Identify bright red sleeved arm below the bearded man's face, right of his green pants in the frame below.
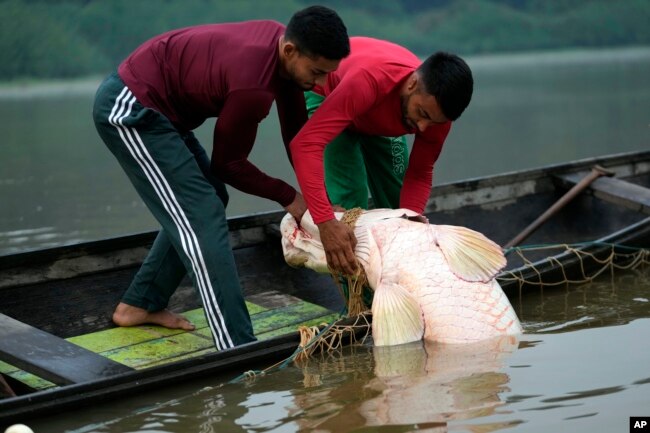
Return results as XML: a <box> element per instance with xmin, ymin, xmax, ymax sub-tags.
<box><xmin>400</xmin><ymin>122</ymin><xmax>451</xmax><ymax>214</ymax></box>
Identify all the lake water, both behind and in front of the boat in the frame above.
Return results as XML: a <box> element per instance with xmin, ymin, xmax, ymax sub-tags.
<box><xmin>0</xmin><ymin>48</ymin><xmax>650</xmax><ymax>433</ymax></box>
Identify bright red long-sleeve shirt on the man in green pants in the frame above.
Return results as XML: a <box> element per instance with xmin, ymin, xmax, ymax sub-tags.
<box><xmin>291</xmin><ymin>37</ymin><xmax>451</xmax><ymax>223</ymax></box>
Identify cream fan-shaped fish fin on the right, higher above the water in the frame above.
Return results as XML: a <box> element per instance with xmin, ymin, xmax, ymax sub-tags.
<box><xmin>430</xmin><ymin>225</ymin><xmax>506</xmax><ymax>282</ymax></box>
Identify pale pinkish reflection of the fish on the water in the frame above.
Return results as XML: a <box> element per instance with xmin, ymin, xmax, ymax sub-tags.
<box><xmin>361</xmin><ymin>336</ymin><xmax>518</xmax><ymax>431</ymax></box>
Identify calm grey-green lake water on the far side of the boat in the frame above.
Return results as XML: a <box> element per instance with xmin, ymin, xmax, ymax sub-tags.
<box><xmin>0</xmin><ymin>47</ymin><xmax>650</xmax><ymax>255</ymax></box>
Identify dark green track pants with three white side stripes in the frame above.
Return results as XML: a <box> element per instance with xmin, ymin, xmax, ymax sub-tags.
<box><xmin>93</xmin><ymin>74</ymin><xmax>255</xmax><ymax>350</ymax></box>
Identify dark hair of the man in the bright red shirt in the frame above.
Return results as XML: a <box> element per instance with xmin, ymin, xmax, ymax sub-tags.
<box><xmin>418</xmin><ymin>52</ymin><xmax>474</xmax><ymax>120</ymax></box>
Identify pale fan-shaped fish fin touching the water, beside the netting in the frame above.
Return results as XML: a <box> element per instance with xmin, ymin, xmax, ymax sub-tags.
<box><xmin>372</xmin><ymin>283</ymin><xmax>424</xmax><ymax>346</ymax></box>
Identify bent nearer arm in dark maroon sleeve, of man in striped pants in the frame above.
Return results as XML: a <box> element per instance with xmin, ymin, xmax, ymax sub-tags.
<box><xmin>211</xmin><ymin>90</ymin><xmax>296</xmax><ymax>207</ymax></box>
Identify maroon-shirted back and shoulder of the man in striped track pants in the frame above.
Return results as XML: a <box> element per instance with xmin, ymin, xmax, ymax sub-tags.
<box><xmin>118</xmin><ymin>21</ymin><xmax>284</xmax><ymax>130</ymax></box>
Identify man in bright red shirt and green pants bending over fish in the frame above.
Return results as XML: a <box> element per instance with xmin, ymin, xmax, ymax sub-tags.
<box><xmin>291</xmin><ymin>37</ymin><xmax>473</xmax><ymax>275</ymax></box>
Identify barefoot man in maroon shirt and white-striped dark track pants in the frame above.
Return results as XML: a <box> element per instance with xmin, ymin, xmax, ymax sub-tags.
<box><xmin>93</xmin><ymin>6</ymin><xmax>350</xmax><ymax>349</ymax></box>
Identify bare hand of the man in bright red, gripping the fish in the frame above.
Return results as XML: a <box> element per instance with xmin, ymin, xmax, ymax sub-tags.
<box><xmin>318</xmin><ymin>218</ymin><xmax>357</xmax><ymax>275</ymax></box>
